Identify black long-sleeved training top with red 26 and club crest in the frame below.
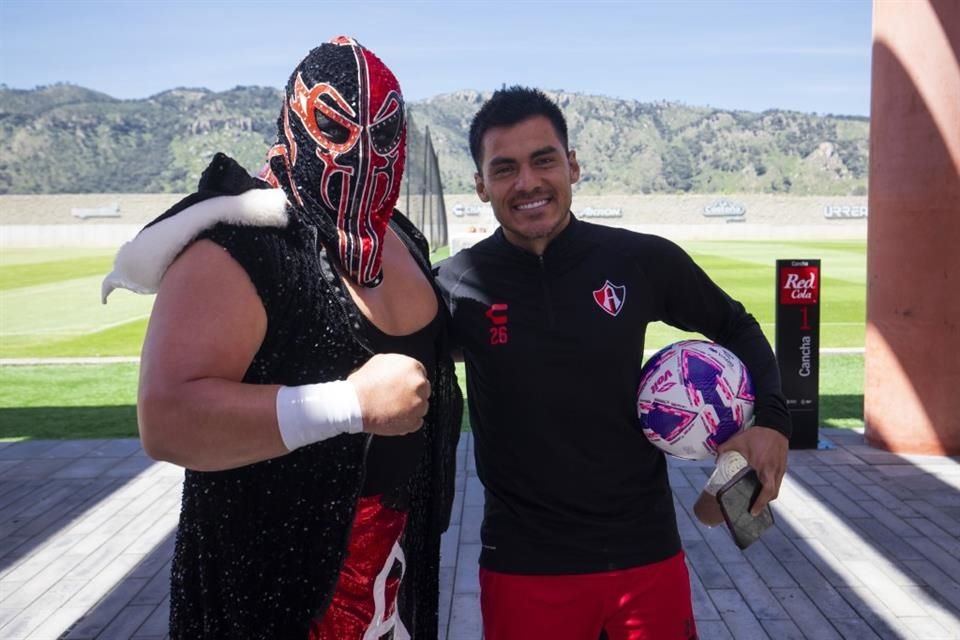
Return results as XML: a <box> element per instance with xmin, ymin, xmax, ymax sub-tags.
<box><xmin>437</xmin><ymin>219</ymin><xmax>790</xmax><ymax>575</ymax></box>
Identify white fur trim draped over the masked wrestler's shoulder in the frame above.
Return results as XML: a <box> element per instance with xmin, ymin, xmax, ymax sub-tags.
<box><xmin>100</xmin><ymin>189</ymin><xmax>287</xmax><ymax>304</ymax></box>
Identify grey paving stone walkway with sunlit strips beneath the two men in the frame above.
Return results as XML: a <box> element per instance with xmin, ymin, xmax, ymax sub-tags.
<box><xmin>0</xmin><ymin>429</ymin><xmax>960</xmax><ymax>640</ymax></box>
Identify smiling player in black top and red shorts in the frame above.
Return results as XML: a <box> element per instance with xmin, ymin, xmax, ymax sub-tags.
<box><xmin>438</xmin><ymin>87</ymin><xmax>790</xmax><ymax>640</ymax></box>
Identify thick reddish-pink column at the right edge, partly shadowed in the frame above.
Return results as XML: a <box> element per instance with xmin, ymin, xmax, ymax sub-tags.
<box><xmin>864</xmin><ymin>0</ymin><xmax>960</xmax><ymax>455</ymax></box>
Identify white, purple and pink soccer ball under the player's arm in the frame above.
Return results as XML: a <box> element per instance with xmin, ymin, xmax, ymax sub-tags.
<box><xmin>637</xmin><ymin>340</ymin><xmax>754</xmax><ymax>460</ymax></box>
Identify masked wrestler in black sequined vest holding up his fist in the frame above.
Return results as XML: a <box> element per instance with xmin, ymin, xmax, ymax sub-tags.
<box><xmin>104</xmin><ymin>37</ymin><xmax>461</xmax><ymax>640</ymax></box>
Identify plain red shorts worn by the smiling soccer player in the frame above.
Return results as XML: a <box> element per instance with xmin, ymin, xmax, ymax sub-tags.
<box><xmin>480</xmin><ymin>552</ymin><xmax>697</xmax><ymax>640</ymax></box>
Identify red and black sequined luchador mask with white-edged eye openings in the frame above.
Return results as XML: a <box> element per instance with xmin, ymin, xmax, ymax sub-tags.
<box><xmin>262</xmin><ymin>36</ymin><xmax>406</xmax><ymax>286</ymax></box>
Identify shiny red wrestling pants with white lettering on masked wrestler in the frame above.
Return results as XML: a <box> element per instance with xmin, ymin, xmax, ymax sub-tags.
<box><xmin>308</xmin><ymin>496</ymin><xmax>410</xmax><ymax>640</ymax></box>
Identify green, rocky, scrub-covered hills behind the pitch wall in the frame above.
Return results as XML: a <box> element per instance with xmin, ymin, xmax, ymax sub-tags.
<box><xmin>0</xmin><ymin>84</ymin><xmax>869</xmax><ymax>195</ymax></box>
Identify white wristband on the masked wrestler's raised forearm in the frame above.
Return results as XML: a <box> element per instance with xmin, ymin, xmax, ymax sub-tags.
<box><xmin>277</xmin><ymin>380</ymin><xmax>363</xmax><ymax>451</ymax></box>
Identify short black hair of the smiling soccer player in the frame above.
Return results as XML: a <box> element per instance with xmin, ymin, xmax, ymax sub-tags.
<box><xmin>470</xmin><ymin>85</ymin><xmax>570</xmax><ymax>171</ymax></box>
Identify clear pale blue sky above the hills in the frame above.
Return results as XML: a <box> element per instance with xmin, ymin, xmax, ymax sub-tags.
<box><xmin>0</xmin><ymin>0</ymin><xmax>871</xmax><ymax>116</ymax></box>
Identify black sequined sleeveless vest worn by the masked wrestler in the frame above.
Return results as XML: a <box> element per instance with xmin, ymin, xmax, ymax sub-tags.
<box><xmin>170</xmin><ymin>213</ymin><xmax>462</xmax><ymax>640</ymax></box>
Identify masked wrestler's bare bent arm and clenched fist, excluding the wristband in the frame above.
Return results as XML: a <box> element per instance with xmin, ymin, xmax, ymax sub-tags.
<box><xmin>138</xmin><ymin>240</ymin><xmax>429</xmax><ymax>471</ymax></box>
